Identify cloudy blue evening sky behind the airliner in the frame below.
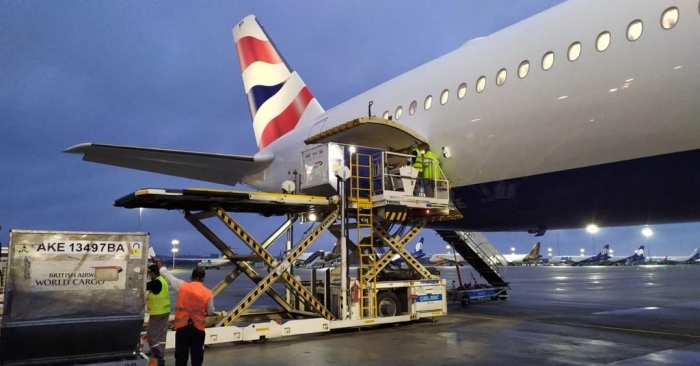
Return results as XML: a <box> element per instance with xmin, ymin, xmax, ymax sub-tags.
<box><xmin>0</xmin><ymin>0</ymin><xmax>699</xmax><ymax>256</ymax></box>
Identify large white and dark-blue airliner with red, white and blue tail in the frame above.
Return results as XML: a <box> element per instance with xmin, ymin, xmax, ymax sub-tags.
<box><xmin>65</xmin><ymin>0</ymin><xmax>700</xmax><ymax>235</ymax></box>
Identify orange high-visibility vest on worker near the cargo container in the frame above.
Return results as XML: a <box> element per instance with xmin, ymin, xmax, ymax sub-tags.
<box><xmin>173</xmin><ymin>281</ymin><xmax>212</xmax><ymax>331</ymax></box>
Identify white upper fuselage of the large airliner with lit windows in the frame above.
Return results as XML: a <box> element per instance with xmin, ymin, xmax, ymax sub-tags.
<box><xmin>243</xmin><ymin>0</ymin><xmax>700</xmax><ymax>191</ymax></box>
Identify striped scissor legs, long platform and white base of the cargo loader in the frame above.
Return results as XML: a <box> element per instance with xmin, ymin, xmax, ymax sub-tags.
<box><xmin>114</xmin><ymin>188</ymin><xmax>447</xmax><ymax>348</ymax></box>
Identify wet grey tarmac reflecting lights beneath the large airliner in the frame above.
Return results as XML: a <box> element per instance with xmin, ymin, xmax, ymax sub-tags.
<box><xmin>166</xmin><ymin>265</ymin><xmax>700</xmax><ymax>366</ymax></box>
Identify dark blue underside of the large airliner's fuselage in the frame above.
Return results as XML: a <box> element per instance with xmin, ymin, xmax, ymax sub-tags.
<box><xmin>438</xmin><ymin>150</ymin><xmax>700</xmax><ymax>231</ymax></box>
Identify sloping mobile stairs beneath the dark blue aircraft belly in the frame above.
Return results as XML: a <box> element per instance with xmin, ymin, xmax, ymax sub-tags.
<box><xmin>437</xmin><ymin>230</ymin><xmax>508</xmax><ymax>287</ymax></box>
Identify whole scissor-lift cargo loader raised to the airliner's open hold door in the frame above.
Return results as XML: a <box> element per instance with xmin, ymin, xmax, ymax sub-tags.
<box><xmin>115</xmin><ymin>133</ymin><xmax>508</xmax><ymax>348</ymax></box>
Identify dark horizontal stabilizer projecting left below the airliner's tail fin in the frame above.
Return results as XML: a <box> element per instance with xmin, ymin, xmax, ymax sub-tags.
<box><xmin>64</xmin><ymin>143</ymin><xmax>274</xmax><ymax>185</ymax></box>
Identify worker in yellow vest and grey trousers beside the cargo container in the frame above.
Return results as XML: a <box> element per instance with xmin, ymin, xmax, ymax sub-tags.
<box><xmin>146</xmin><ymin>264</ymin><xmax>170</xmax><ymax>366</ymax></box>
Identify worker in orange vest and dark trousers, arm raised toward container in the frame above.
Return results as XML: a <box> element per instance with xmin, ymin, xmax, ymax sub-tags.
<box><xmin>154</xmin><ymin>258</ymin><xmax>214</xmax><ymax>366</ymax></box>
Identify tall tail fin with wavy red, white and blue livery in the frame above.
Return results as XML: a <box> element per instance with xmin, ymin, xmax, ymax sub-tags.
<box><xmin>233</xmin><ymin>15</ymin><xmax>324</xmax><ymax>149</ymax></box>
